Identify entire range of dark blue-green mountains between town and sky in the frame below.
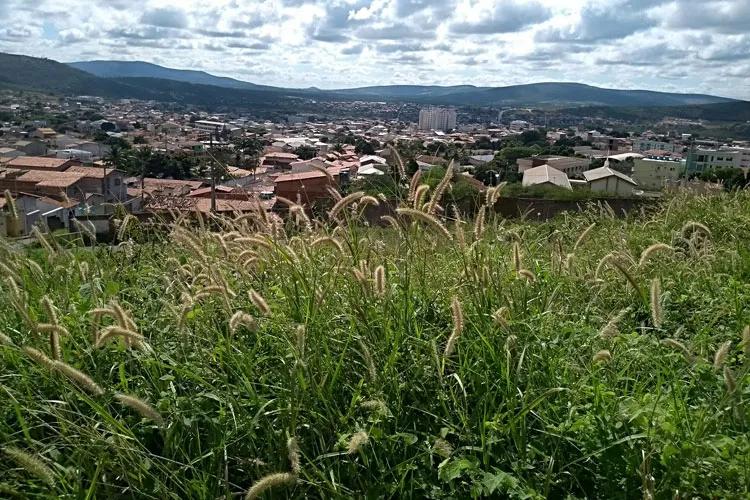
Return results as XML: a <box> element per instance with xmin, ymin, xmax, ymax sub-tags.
<box><xmin>0</xmin><ymin>53</ymin><xmax>750</xmax><ymax>121</ymax></box>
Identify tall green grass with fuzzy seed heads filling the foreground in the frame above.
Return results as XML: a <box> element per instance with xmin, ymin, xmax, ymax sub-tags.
<box><xmin>0</xmin><ymin>186</ymin><xmax>750</xmax><ymax>499</ymax></box>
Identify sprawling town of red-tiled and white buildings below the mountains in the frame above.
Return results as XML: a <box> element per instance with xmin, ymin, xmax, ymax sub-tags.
<box><xmin>0</xmin><ymin>92</ymin><xmax>750</xmax><ymax>236</ymax></box>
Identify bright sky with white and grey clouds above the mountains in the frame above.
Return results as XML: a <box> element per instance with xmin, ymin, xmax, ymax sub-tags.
<box><xmin>0</xmin><ymin>0</ymin><xmax>750</xmax><ymax>100</ymax></box>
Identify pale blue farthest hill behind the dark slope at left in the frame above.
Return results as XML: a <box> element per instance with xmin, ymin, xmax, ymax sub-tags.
<box><xmin>68</xmin><ymin>61</ymin><xmax>281</xmax><ymax>90</ymax></box>
